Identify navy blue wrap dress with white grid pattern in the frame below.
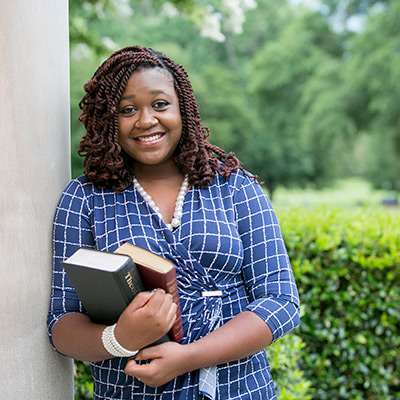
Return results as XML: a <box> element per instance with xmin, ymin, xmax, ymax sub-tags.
<box><xmin>48</xmin><ymin>171</ymin><xmax>299</xmax><ymax>400</ymax></box>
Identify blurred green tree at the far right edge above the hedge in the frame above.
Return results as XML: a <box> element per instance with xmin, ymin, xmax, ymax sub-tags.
<box><xmin>346</xmin><ymin>0</ymin><xmax>400</xmax><ymax>190</ymax></box>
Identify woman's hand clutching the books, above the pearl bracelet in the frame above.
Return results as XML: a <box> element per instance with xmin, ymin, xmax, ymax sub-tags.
<box><xmin>114</xmin><ymin>289</ymin><xmax>177</xmax><ymax>351</ymax></box>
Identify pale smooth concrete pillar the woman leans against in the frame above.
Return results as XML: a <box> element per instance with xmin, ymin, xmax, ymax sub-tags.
<box><xmin>0</xmin><ymin>0</ymin><xmax>73</xmax><ymax>400</ymax></box>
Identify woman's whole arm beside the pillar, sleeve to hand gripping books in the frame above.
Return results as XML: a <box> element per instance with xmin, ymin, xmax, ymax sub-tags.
<box><xmin>48</xmin><ymin>179</ymin><xmax>176</xmax><ymax>361</ymax></box>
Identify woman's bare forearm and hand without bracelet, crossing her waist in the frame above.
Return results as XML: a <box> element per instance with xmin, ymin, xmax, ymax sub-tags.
<box><xmin>125</xmin><ymin>311</ymin><xmax>273</xmax><ymax>387</ymax></box>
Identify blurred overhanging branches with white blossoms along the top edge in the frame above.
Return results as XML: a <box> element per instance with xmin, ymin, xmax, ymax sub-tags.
<box><xmin>69</xmin><ymin>0</ymin><xmax>257</xmax><ymax>54</ymax></box>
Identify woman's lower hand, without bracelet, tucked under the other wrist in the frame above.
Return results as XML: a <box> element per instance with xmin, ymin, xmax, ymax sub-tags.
<box><xmin>125</xmin><ymin>342</ymin><xmax>191</xmax><ymax>387</ymax></box>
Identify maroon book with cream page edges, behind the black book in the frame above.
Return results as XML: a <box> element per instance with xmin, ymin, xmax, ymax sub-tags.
<box><xmin>114</xmin><ymin>242</ymin><xmax>183</xmax><ymax>343</ymax></box>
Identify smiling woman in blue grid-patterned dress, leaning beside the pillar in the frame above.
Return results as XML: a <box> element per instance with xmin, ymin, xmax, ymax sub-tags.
<box><xmin>48</xmin><ymin>46</ymin><xmax>299</xmax><ymax>400</ymax></box>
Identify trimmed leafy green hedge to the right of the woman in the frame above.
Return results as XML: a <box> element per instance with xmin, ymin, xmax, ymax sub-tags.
<box><xmin>278</xmin><ymin>208</ymin><xmax>400</xmax><ymax>400</ymax></box>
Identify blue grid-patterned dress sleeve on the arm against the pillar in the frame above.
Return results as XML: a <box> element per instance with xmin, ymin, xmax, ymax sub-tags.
<box><xmin>47</xmin><ymin>179</ymin><xmax>94</xmax><ymax>347</ymax></box>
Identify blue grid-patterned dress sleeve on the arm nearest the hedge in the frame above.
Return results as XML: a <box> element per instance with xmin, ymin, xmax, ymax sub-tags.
<box><xmin>234</xmin><ymin>179</ymin><xmax>300</xmax><ymax>342</ymax></box>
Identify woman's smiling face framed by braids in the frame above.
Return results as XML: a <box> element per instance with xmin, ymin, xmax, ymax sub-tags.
<box><xmin>118</xmin><ymin>68</ymin><xmax>182</xmax><ymax>167</ymax></box>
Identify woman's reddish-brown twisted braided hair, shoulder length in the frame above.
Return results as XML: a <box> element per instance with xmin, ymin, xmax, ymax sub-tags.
<box><xmin>78</xmin><ymin>46</ymin><xmax>245</xmax><ymax>193</ymax></box>
